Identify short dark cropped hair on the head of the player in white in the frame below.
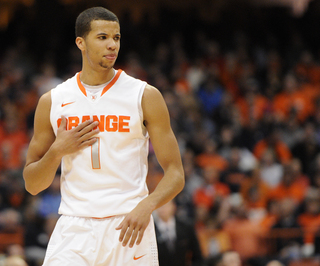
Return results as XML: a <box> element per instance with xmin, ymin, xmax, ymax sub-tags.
<box><xmin>75</xmin><ymin>7</ymin><xmax>120</xmax><ymax>37</ymax></box>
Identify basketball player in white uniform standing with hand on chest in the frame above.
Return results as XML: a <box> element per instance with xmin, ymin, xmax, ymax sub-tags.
<box><xmin>24</xmin><ymin>7</ymin><xmax>184</xmax><ymax>266</ymax></box>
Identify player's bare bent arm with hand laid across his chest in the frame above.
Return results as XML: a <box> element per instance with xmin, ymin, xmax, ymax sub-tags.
<box><xmin>23</xmin><ymin>92</ymin><xmax>99</xmax><ymax>195</ymax></box>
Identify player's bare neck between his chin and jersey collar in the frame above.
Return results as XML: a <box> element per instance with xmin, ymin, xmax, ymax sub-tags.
<box><xmin>80</xmin><ymin>68</ymin><xmax>115</xmax><ymax>86</ymax></box>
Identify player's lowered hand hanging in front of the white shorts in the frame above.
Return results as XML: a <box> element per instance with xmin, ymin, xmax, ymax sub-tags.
<box><xmin>116</xmin><ymin>201</ymin><xmax>152</xmax><ymax>248</ymax></box>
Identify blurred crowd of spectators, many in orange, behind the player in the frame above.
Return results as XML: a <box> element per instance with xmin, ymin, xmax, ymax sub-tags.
<box><xmin>0</xmin><ymin>6</ymin><xmax>320</xmax><ymax>266</ymax></box>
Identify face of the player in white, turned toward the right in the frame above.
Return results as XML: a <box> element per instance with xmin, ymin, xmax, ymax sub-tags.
<box><xmin>85</xmin><ymin>20</ymin><xmax>120</xmax><ymax>69</ymax></box>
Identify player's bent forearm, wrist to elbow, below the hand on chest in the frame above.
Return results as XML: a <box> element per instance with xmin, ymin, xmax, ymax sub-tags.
<box><xmin>23</xmin><ymin>147</ymin><xmax>61</xmax><ymax>195</ymax></box>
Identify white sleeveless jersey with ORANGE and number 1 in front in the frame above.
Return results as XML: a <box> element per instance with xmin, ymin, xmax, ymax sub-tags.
<box><xmin>50</xmin><ymin>70</ymin><xmax>149</xmax><ymax>218</ymax></box>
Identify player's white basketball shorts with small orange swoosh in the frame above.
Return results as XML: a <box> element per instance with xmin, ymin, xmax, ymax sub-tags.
<box><xmin>43</xmin><ymin>215</ymin><xmax>159</xmax><ymax>266</ymax></box>
